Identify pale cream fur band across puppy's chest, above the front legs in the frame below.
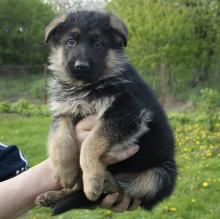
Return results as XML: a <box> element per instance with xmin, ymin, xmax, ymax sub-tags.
<box><xmin>50</xmin><ymin>97</ymin><xmax>114</xmax><ymax>118</ymax></box>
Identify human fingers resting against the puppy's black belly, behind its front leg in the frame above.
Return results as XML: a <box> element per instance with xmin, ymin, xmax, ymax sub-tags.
<box><xmin>102</xmin><ymin>145</ymin><xmax>139</xmax><ymax>165</ymax></box>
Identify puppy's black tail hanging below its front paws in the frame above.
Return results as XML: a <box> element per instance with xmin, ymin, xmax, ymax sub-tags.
<box><xmin>52</xmin><ymin>190</ymin><xmax>105</xmax><ymax>215</ymax></box>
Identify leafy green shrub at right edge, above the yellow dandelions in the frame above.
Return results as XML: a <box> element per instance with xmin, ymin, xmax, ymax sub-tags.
<box><xmin>198</xmin><ymin>88</ymin><xmax>220</xmax><ymax>131</ymax></box>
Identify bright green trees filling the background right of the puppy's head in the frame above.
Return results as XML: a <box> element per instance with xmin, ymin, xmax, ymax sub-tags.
<box><xmin>107</xmin><ymin>0</ymin><xmax>220</xmax><ymax>98</ymax></box>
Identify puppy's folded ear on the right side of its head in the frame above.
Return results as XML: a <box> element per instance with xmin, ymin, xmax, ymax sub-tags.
<box><xmin>109</xmin><ymin>13</ymin><xmax>128</xmax><ymax>47</ymax></box>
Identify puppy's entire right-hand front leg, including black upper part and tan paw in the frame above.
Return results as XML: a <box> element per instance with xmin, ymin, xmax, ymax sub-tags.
<box><xmin>80</xmin><ymin>96</ymin><xmax>147</xmax><ymax>201</ymax></box>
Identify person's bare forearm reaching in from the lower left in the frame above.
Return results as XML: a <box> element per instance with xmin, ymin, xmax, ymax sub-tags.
<box><xmin>0</xmin><ymin>159</ymin><xmax>60</xmax><ymax>219</ymax></box>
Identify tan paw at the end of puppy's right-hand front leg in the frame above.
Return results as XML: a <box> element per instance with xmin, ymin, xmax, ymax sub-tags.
<box><xmin>83</xmin><ymin>174</ymin><xmax>105</xmax><ymax>201</ymax></box>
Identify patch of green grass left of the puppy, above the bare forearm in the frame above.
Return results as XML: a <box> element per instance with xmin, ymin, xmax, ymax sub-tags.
<box><xmin>0</xmin><ymin>114</ymin><xmax>50</xmax><ymax>166</ymax></box>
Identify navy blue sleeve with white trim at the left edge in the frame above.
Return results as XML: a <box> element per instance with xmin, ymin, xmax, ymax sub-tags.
<box><xmin>0</xmin><ymin>143</ymin><xmax>28</xmax><ymax>182</ymax></box>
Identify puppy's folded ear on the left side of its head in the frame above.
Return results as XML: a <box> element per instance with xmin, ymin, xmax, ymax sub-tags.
<box><xmin>44</xmin><ymin>15</ymin><xmax>67</xmax><ymax>43</ymax></box>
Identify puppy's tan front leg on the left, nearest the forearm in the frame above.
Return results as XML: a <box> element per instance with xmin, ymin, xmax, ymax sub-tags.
<box><xmin>49</xmin><ymin>116</ymin><xmax>79</xmax><ymax>189</ymax></box>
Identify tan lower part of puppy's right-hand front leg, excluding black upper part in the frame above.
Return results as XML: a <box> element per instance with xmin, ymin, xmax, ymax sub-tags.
<box><xmin>80</xmin><ymin>122</ymin><xmax>110</xmax><ymax>201</ymax></box>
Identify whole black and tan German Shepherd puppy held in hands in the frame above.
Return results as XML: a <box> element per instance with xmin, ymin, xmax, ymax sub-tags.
<box><xmin>38</xmin><ymin>11</ymin><xmax>176</xmax><ymax>214</ymax></box>
